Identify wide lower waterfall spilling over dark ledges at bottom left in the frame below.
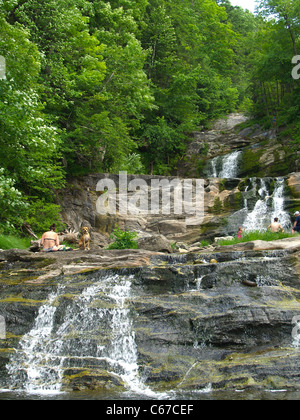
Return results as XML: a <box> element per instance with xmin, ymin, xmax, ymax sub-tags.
<box><xmin>6</xmin><ymin>275</ymin><xmax>162</xmax><ymax>397</ymax></box>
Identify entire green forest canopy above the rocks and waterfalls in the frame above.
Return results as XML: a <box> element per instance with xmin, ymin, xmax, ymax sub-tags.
<box><xmin>0</xmin><ymin>0</ymin><xmax>300</xmax><ymax>232</ymax></box>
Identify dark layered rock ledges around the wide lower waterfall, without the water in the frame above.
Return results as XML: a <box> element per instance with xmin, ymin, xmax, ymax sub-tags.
<box><xmin>0</xmin><ymin>238</ymin><xmax>300</xmax><ymax>391</ymax></box>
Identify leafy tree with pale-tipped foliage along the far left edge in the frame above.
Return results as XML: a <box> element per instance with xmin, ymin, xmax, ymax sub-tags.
<box><xmin>0</xmin><ymin>13</ymin><xmax>64</xmax><ymax>227</ymax></box>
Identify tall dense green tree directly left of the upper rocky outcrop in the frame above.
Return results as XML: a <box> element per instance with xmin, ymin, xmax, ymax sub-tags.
<box><xmin>140</xmin><ymin>0</ymin><xmax>238</xmax><ymax>174</ymax></box>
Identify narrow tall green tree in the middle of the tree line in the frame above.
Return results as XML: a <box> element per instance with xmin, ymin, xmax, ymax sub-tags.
<box><xmin>86</xmin><ymin>0</ymin><xmax>154</xmax><ymax>171</ymax></box>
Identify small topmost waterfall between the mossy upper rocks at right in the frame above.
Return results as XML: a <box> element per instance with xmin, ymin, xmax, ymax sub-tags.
<box><xmin>208</xmin><ymin>150</ymin><xmax>242</xmax><ymax>178</ymax></box>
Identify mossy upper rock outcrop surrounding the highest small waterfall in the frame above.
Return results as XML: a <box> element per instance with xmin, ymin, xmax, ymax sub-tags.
<box><xmin>178</xmin><ymin>114</ymin><xmax>300</xmax><ymax>178</ymax></box>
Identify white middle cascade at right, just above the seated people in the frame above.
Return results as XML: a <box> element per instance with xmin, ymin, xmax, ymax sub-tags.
<box><xmin>243</xmin><ymin>178</ymin><xmax>291</xmax><ymax>232</ymax></box>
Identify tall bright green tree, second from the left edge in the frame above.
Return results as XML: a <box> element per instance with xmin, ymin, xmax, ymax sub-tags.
<box><xmin>14</xmin><ymin>0</ymin><xmax>106</xmax><ymax>172</ymax></box>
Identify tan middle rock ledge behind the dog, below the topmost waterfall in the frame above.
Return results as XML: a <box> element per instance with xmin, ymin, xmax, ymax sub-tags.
<box><xmin>58</xmin><ymin>172</ymin><xmax>300</xmax><ymax>252</ymax></box>
